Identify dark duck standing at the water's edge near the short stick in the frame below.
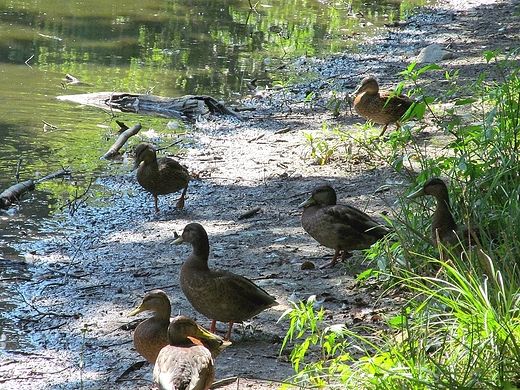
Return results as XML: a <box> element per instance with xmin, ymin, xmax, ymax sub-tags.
<box><xmin>134</xmin><ymin>143</ymin><xmax>190</xmax><ymax>213</ymax></box>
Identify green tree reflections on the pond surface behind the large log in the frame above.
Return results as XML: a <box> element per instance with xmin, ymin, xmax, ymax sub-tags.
<box><xmin>0</xmin><ymin>0</ymin><xmax>423</xmax><ymax>99</ymax></box>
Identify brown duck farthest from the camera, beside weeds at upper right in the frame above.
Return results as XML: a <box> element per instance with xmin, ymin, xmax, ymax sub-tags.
<box><xmin>353</xmin><ymin>77</ymin><xmax>415</xmax><ymax>136</ymax></box>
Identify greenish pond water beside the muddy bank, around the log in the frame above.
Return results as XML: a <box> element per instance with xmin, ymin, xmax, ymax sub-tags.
<box><xmin>0</xmin><ymin>0</ymin><xmax>425</xmax><ymax>350</ymax></box>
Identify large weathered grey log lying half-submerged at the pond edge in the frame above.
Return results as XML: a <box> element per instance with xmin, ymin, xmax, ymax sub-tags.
<box><xmin>58</xmin><ymin>92</ymin><xmax>241</xmax><ymax>119</ymax></box>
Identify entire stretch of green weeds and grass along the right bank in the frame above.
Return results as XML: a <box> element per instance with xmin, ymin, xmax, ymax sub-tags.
<box><xmin>283</xmin><ymin>51</ymin><xmax>520</xmax><ymax>389</ymax></box>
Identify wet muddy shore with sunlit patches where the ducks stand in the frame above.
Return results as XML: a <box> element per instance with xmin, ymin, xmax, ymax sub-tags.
<box><xmin>0</xmin><ymin>0</ymin><xmax>520</xmax><ymax>389</ymax></box>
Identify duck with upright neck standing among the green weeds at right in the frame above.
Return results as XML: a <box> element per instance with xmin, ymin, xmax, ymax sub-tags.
<box><xmin>407</xmin><ymin>177</ymin><xmax>467</xmax><ymax>258</ymax></box>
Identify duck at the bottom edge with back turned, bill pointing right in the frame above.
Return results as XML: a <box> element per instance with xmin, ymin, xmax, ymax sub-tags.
<box><xmin>153</xmin><ymin>316</ymin><xmax>221</xmax><ymax>390</ymax></box>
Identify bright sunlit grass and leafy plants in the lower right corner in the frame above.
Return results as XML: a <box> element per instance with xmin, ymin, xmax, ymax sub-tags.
<box><xmin>280</xmin><ymin>252</ymin><xmax>520</xmax><ymax>390</ymax></box>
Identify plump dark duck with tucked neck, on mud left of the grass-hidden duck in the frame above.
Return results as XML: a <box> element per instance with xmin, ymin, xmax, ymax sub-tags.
<box><xmin>299</xmin><ymin>185</ymin><xmax>389</xmax><ymax>268</ymax></box>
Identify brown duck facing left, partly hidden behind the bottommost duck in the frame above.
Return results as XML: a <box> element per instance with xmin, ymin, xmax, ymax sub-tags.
<box><xmin>128</xmin><ymin>289</ymin><xmax>231</xmax><ymax>364</ymax></box>
